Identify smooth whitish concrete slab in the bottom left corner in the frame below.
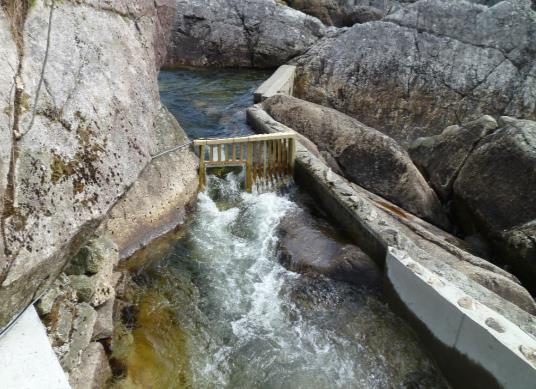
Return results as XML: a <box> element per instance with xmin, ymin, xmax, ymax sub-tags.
<box><xmin>0</xmin><ymin>306</ymin><xmax>70</xmax><ymax>389</ymax></box>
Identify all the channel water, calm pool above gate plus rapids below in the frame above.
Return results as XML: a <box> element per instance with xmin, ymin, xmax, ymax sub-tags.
<box><xmin>114</xmin><ymin>70</ymin><xmax>447</xmax><ymax>389</ymax></box>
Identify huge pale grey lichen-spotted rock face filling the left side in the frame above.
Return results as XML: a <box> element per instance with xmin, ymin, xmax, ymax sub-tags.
<box><xmin>0</xmin><ymin>0</ymin><xmax>174</xmax><ymax>326</ymax></box>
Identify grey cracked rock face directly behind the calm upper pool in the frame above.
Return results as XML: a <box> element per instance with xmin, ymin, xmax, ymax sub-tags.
<box><xmin>166</xmin><ymin>0</ymin><xmax>325</xmax><ymax>67</ymax></box>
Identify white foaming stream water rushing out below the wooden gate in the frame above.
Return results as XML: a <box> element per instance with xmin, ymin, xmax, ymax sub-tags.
<box><xmin>117</xmin><ymin>174</ymin><xmax>444</xmax><ymax>389</ymax></box>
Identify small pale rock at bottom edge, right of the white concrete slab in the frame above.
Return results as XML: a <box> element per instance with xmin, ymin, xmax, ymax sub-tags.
<box><xmin>69</xmin><ymin>342</ymin><xmax>112</xmax><ymax>389</ymax></box>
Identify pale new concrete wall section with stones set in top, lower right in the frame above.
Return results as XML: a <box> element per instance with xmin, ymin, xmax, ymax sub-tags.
<box><xmin>386</xmin><ymin>247</ymin><xmax>536</xmax><ymax>388</ymax></box>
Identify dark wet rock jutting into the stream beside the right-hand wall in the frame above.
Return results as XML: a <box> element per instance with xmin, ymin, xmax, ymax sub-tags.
<box><xmin>279</xmin><ymin>203</ymin><xmax>381</xmax><ymax>289</ymax></box>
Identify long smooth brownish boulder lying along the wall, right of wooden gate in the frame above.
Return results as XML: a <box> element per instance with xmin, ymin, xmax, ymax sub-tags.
<box><xmin>263</xmin><ymin>95</ymin><xmax>448</xmax><ymax>226</ymax></box>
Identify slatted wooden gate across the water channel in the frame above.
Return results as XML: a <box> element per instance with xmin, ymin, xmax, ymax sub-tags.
<box><xmin>194</xmin><ymin>132</ymin><xmax>296</xmax><ymax>192</ymax></box>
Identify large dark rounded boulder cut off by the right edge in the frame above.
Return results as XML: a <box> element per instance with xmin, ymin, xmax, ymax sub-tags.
<box><xmin>454</xmin><ymin>117</ymin><xmax>536</xmax><ymax>285</ymax></box>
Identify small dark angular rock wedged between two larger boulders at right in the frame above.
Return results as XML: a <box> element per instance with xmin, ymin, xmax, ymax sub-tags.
<box><xmin>408</xmin><ymin>116</ymin><xmax>498</xmax><ymax>201</ymax></box>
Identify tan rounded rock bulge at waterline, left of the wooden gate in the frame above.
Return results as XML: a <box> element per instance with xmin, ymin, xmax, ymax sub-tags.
<box><xmin>99</xmin><ymin>107</ymin><xmax>199</xmax><ymax>258</ymax></box>
